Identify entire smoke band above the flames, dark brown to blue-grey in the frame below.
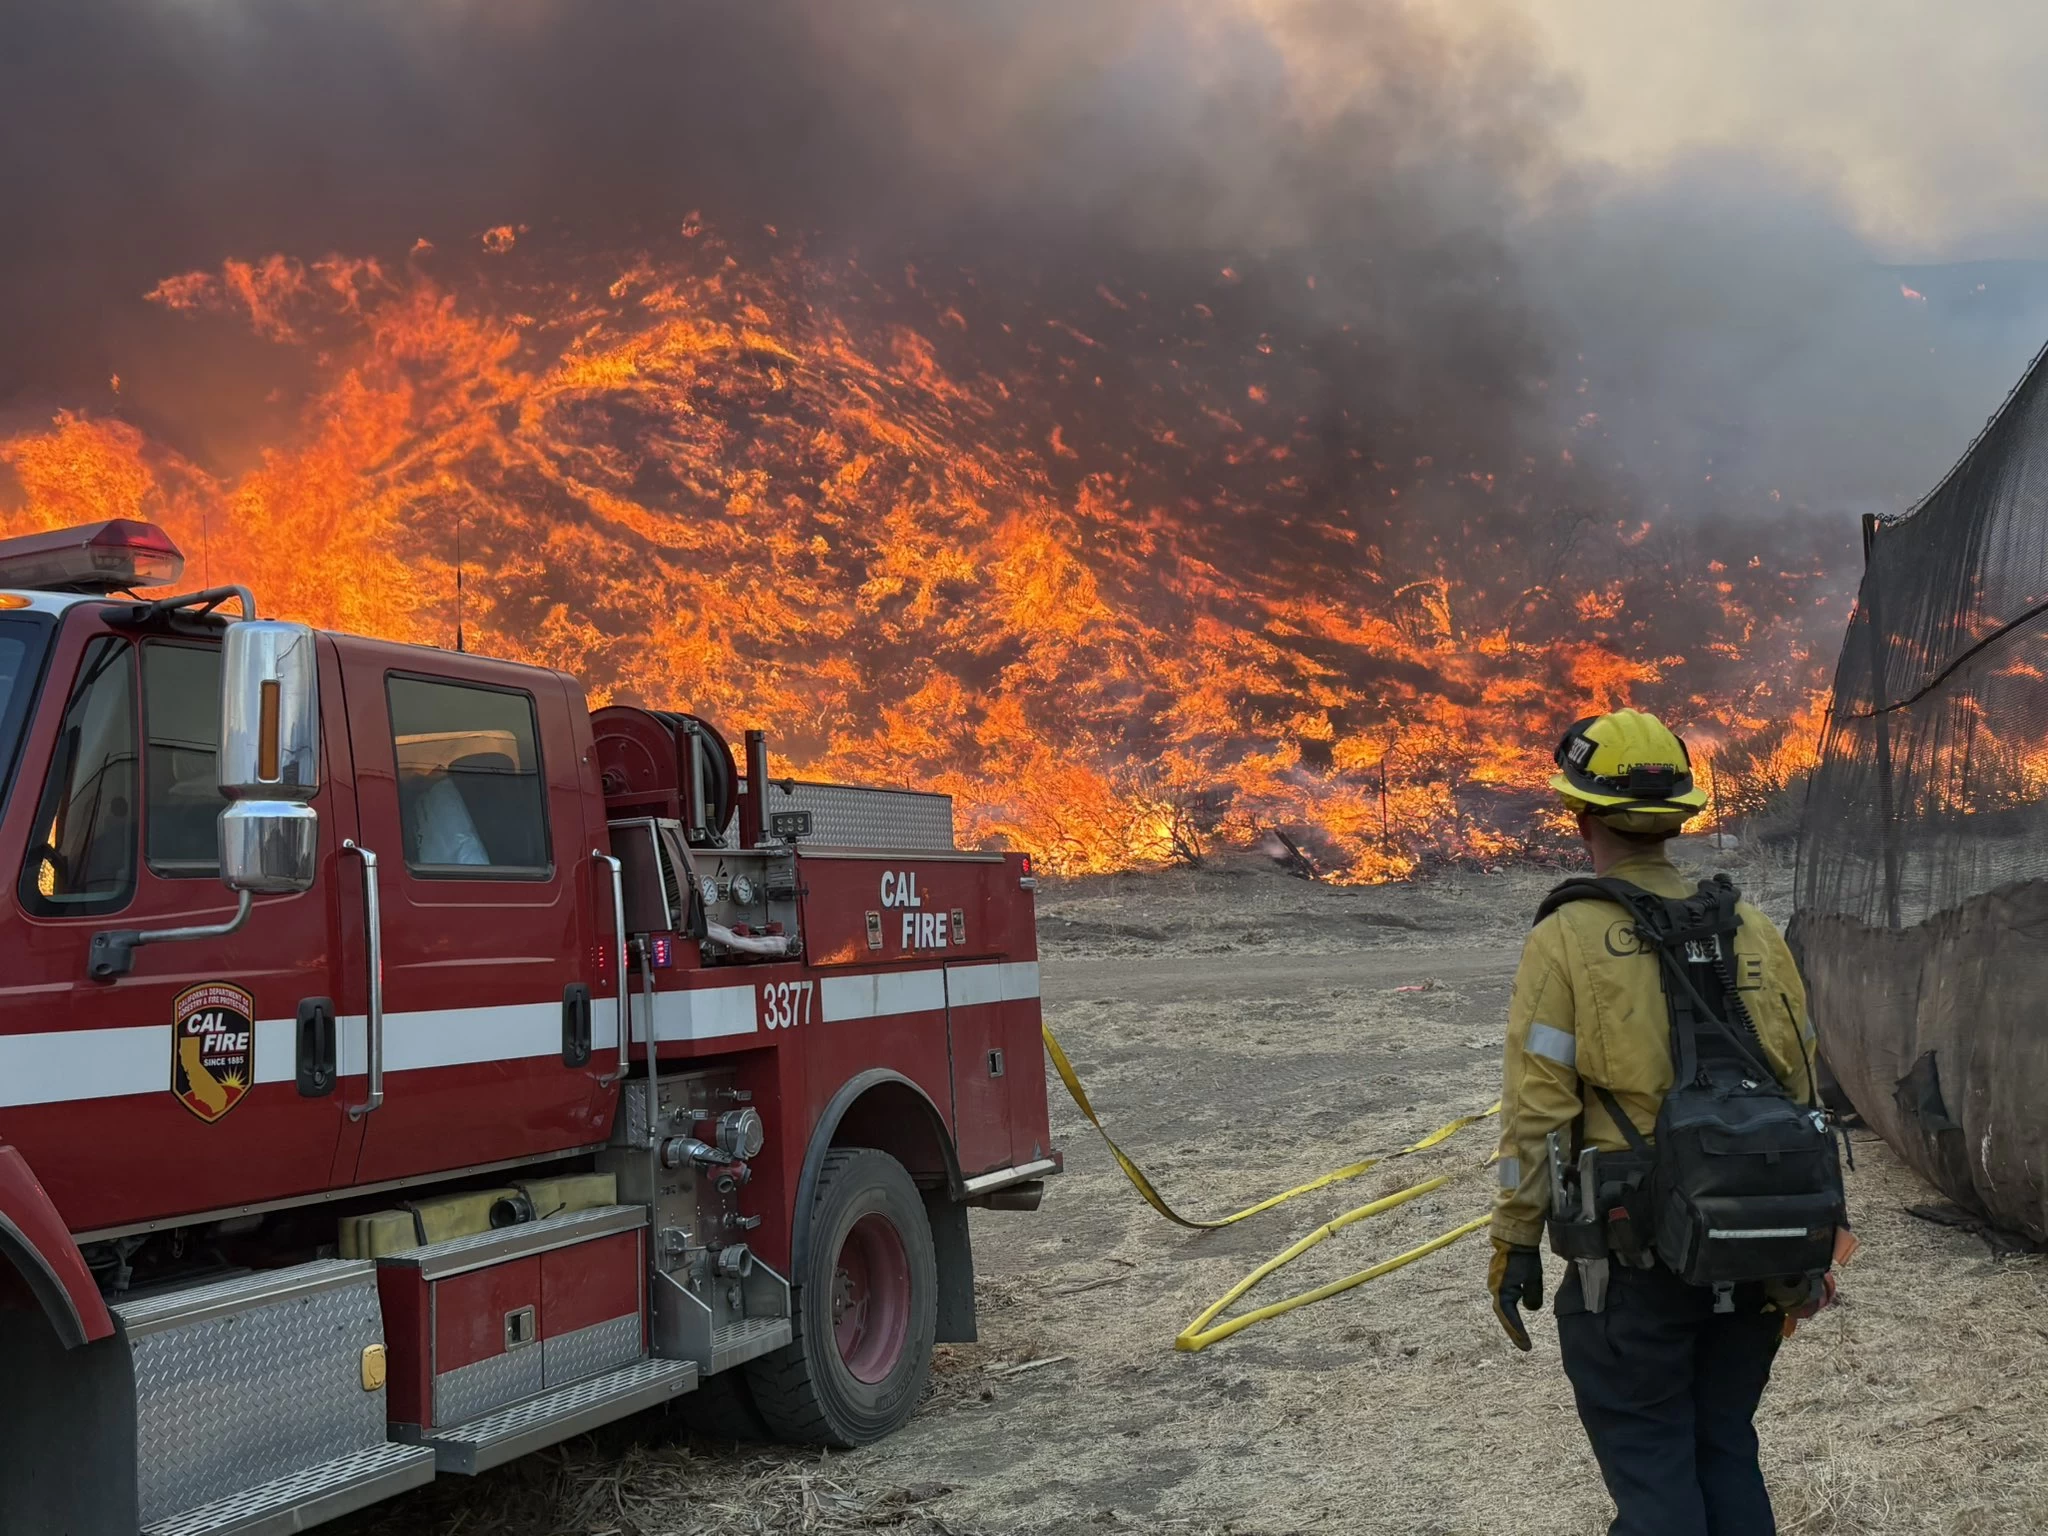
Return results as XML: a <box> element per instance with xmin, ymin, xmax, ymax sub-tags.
<box><xmin>12</xmin><ymin>0</ymin><xmax>2040</xmax><ymax>508</ymax></box>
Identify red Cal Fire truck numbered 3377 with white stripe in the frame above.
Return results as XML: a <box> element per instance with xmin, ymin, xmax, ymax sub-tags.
<box><xmin>0</xmin><ymin>520</ymin><xmax>1059</xmax><ymax>1536</ymax></box>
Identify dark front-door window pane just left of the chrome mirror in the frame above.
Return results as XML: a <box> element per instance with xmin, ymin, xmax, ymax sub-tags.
<box><xmin>141</xmin><ymin>641</ymin><xmax>227</xmax><ymax>877</ymax></box>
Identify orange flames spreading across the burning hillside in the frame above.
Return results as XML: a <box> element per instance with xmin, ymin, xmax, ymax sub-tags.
<box><xmin>0</xmin><ymin>228</ymin><xmax>1839</xmax><ymax>879</ymax></box>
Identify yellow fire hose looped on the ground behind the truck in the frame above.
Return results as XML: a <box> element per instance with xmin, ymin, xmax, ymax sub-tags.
<box><xmin>1040</xmin><ymin>1026</ymin><xmax>1501</xmax><ymax>1352</ymax></box>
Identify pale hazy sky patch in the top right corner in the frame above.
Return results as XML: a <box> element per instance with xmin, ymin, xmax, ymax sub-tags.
<box><xmin>1515</xmin><ymin>0</ymin><xmax>2048</xmax><ymax>260</ymax></box>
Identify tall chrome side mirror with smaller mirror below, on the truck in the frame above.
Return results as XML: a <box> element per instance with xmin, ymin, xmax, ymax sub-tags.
<box><xmin>215</xmin><ymin>618</ymin><xmax>319</xmax><ymax>895</ymax></box>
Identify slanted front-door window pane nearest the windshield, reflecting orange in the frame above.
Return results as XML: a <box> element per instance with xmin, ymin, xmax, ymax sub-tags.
<box><xmin>18</xmin><ymin>639</ymin><xmax>137</xmax><ymax>918</ymax></box>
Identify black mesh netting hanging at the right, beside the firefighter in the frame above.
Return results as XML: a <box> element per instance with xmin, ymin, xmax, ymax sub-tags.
<box><xmin>1796</xmin><ymin>354</ymin><xmax>2048</xmax><ymax>1239</ymax></box>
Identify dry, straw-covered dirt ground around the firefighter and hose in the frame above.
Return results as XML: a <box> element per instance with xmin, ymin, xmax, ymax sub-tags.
<box><xmin>348</xmin><ymin>846</ymin><xmax>2048</xmax><ymax>1536</ymax></box>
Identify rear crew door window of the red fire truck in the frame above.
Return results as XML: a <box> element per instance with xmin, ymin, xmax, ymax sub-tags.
<box><xmin>385</xmin><ymin>676</ymin><xmax>551</xmax><ymax>881</ymax></box>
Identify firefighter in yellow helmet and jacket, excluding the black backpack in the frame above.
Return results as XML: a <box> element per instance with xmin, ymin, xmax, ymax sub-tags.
<box><xmin>1487</xmin><ymin>709</ymin><xmax>1812</xmax><ymax>1536</ymax></box>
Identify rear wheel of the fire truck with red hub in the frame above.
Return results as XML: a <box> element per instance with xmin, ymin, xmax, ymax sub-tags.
<box><xmin>748</xmin><ymin>1147</ymin><xmax>938</xmax><ymax>1446</ymax></box>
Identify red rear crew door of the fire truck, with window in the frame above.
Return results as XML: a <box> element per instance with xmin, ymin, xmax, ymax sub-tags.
<box><xmin>344</xmin><ymin>641</ymin><xmax>616</xmax><ymax>1182</ymax></box>
